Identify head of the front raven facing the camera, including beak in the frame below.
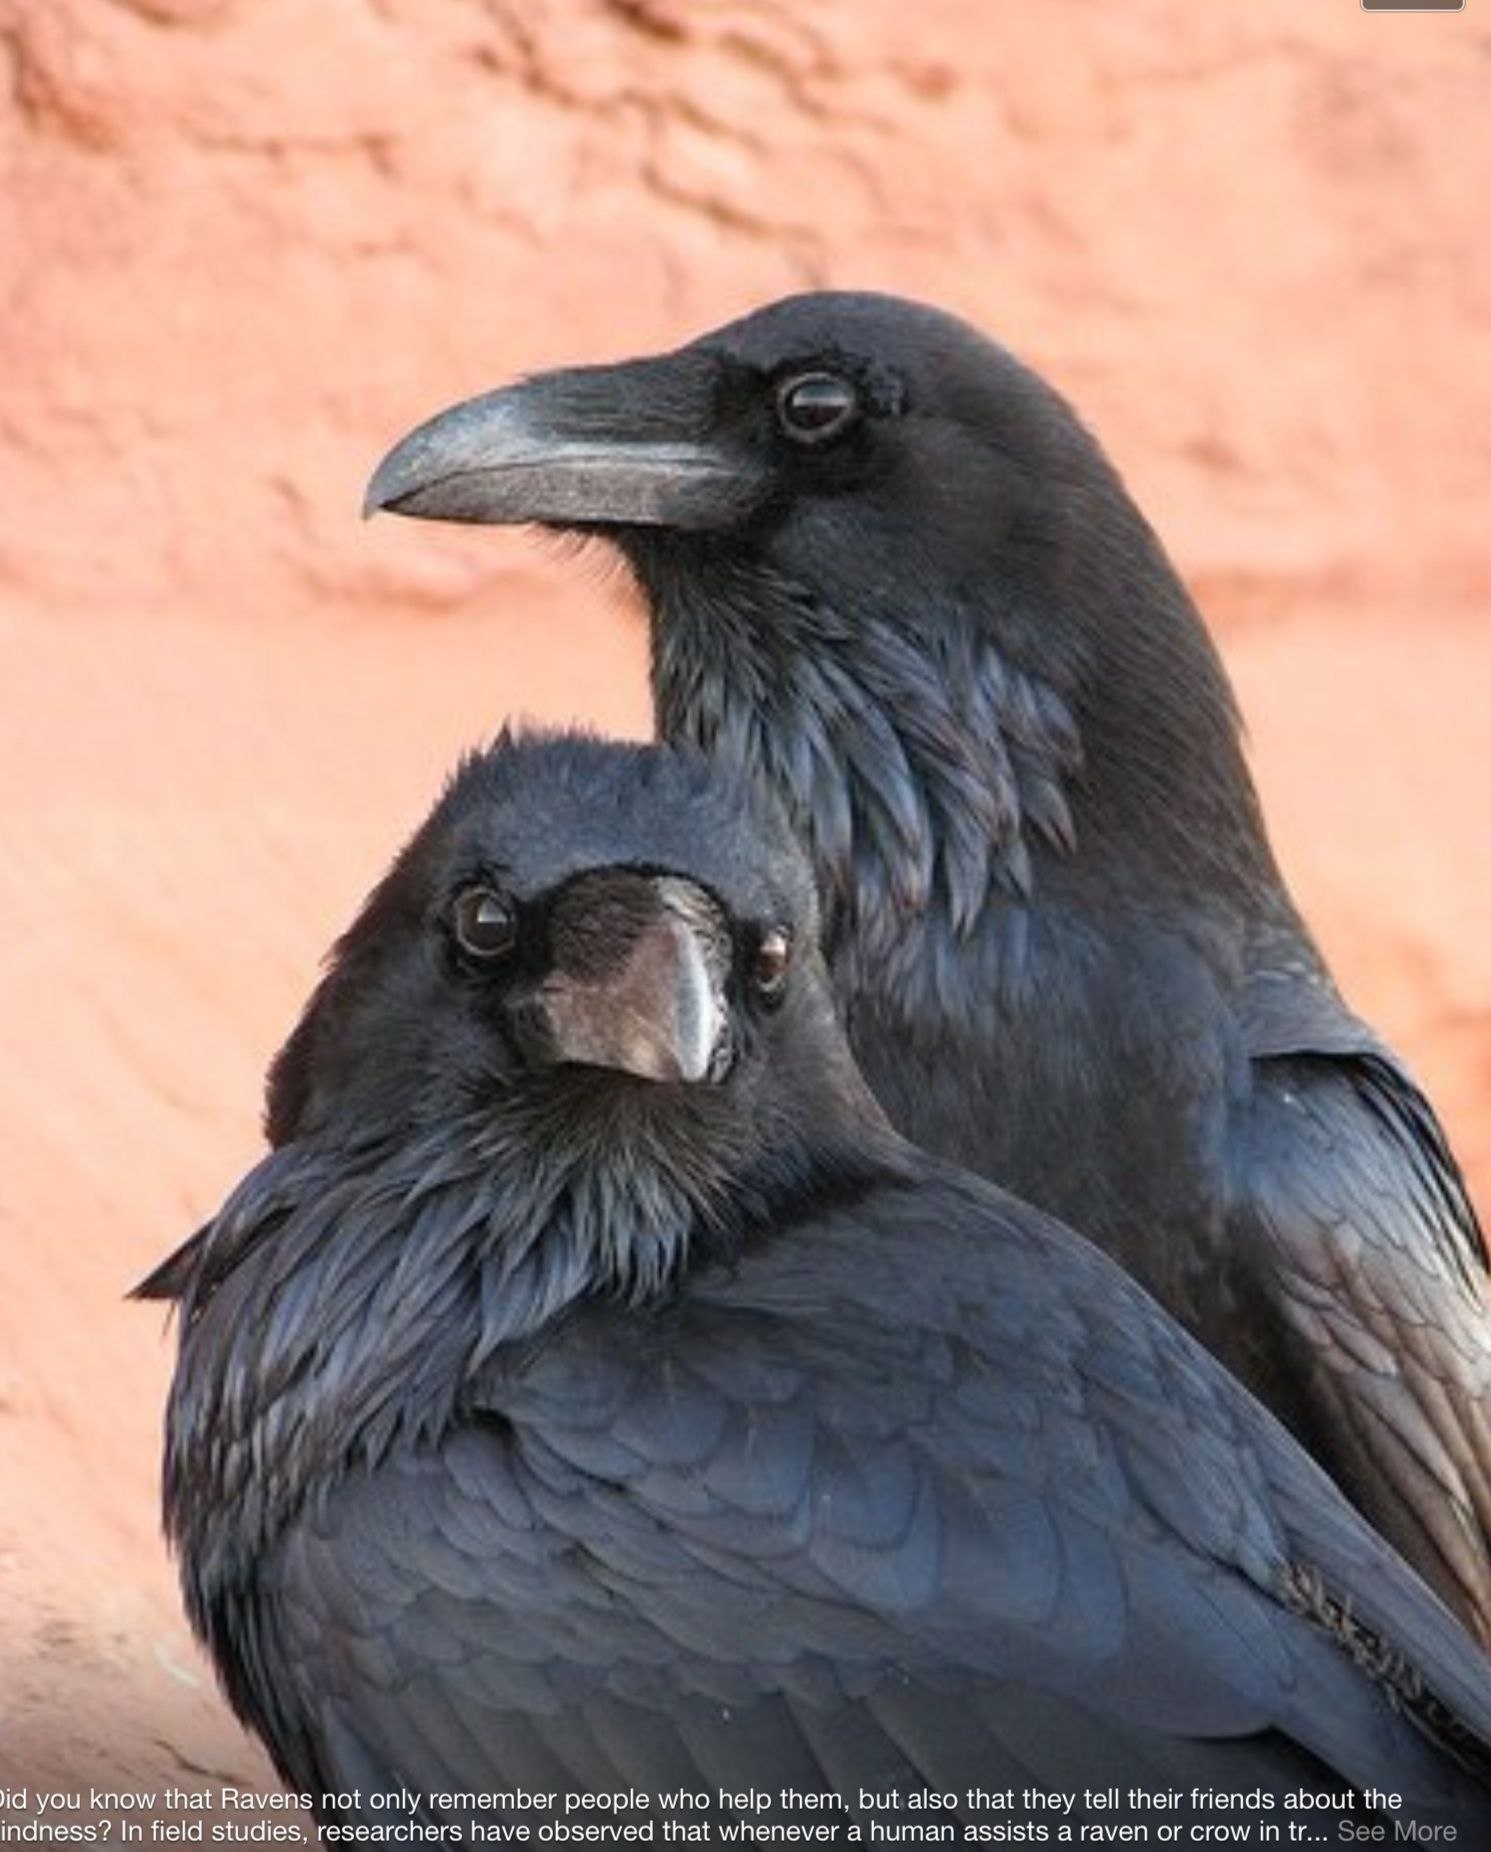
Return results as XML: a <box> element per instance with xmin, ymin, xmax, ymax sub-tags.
<box><xmin>267</xmin><ymin>735</ymin><xmax>866</xmax><ymax>1148</ymax></box>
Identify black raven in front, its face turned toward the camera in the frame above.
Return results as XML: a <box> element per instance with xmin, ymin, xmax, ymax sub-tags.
<box><xmin>141</xmin><ymin>737</ymin><xmax>1491</xmax><ymax>1843</ymax></box>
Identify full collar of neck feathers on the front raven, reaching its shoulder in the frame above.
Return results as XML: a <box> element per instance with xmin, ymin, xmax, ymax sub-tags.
<box><xmin>165</xmin><ymin>1070</ymin><xmax>898</xmax><ymax>1611</ymax></box>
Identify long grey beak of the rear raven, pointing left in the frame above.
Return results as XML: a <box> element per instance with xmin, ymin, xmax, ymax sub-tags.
<box><xmin>363</xmin><ymin>348</ymin><xmax>765</xmax><ymax>530</ymax></box>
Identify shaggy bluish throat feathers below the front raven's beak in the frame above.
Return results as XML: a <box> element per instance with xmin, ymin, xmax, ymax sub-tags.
<box><xmin>167</xmin><ymin>1120</ymin><xmax>726</xmax><ymax>1565</ymax></box>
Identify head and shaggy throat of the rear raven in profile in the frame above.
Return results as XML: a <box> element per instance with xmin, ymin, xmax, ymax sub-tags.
<box><xmin>367</xmin><ymin>293</ymin><xmax>1258</xmax><ymax>985</ymax></box>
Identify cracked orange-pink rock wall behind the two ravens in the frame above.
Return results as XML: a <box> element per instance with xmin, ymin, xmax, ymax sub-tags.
<box><xmin>0</xmin><ymin>0</ymin><xmax>1491</xmax><ymax>1787</ymax></box>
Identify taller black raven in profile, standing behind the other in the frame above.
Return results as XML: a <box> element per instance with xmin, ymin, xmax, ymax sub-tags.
<box><xmin>369</xmin><ymin>294</ymin><xmax>1491</xmax><ymax>1639</ymax></box>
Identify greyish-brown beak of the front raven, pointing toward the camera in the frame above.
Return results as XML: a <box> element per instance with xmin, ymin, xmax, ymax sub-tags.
<box><xmin>533</xmin><ymin>896</ymin><xmax>730</xmax><ymax>1082</ymax></box>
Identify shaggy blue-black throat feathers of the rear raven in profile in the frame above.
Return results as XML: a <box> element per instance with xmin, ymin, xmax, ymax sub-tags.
<box><xmin>648</xmin><ymin>572</ymin><xmax>1082</xmax><ymax>969</ymax></box>
